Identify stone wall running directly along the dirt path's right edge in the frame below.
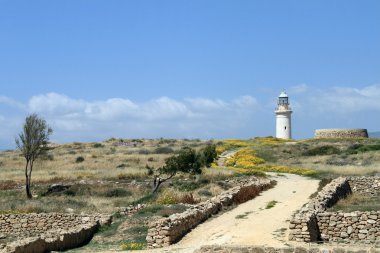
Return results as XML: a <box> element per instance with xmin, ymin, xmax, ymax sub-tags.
<box><xmin>289</xmin><ymin>177</ymin><xmax>351</xmax><ymax>242</ymax></box>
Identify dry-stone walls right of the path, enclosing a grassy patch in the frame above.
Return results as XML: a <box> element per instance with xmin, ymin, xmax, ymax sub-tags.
<box><xmin>289</xmin><ymin>177</ymin><xmax>380</xmax><ymax>244</ymax></box>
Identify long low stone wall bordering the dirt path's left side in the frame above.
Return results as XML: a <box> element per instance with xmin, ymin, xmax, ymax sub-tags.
<box><xmin>147</xmin><ymin>178</ymin><xmax>274</xmax><ymax>248</ymax></box>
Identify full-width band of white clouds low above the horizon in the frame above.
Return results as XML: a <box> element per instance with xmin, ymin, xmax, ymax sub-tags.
<box><xmin>0</xmin><ymin>84</ymin><xmax>380</xmax><ymax>147</ymax></box>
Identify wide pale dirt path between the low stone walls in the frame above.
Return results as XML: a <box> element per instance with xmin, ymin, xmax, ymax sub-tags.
<box><xmin>146</xmin><ymin>174</ymin><xmax>318</xmax><ymax>253</ymax></box>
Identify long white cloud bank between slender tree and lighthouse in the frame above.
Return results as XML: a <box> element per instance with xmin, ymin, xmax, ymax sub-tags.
<box><xmin>0</xmin><ymin>93</ymin><xmax>259</xmax><ymax>142</ymax></box>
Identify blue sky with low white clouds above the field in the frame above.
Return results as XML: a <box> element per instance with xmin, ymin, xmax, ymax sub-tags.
<box><xmin>0</xmin><ymin>0</ymin><xmax>380</xmax><ymax>149</ymax></box>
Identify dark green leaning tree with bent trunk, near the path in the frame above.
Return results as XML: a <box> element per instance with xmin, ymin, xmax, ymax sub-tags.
<box><xmin>151</xmin><ymin>148</ymin><xmax>202</xmax><ymax>192</ymax></box>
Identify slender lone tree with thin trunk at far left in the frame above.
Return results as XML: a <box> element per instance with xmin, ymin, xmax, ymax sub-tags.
<box><xmin>16</xmin><ymin>114</ymin><xmax>53</xmax><ymax>199</ymax></box>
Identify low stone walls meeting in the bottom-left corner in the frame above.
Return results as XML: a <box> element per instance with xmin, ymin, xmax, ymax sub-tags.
<box><xmin>0</xmin><ymin>213</ymin><xmax>112</xmax><ymax>253</ymax></box>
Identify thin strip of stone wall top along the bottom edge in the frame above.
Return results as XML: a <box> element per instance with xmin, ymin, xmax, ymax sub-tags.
<box><xmin>194</xmin><ymin>245</ymin><xmax>380</xmax><ymax>253</ymax></box>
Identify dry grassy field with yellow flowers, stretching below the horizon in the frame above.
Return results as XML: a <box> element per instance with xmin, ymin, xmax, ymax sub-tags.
<box><xmin>0</xmin><ymin>137</ymin><xmax>380</xmax><ymax>249</ymax></box>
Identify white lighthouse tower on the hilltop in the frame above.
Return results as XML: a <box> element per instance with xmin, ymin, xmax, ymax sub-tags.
<box><xmin>275</xmin><ymin>91</ymin><xmax>293</xmax><ymax>139</ymax></box>
